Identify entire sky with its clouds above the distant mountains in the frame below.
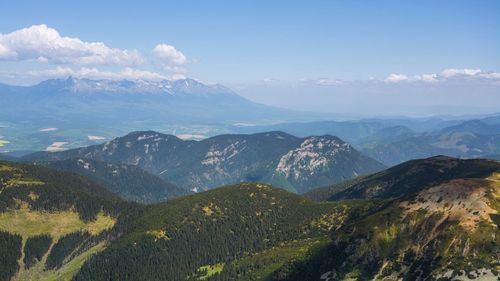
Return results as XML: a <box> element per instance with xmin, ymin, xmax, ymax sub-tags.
<box><xmin>0</xmin><ymin>0</ymin><xmax>500</xmax><ymax>115</ymax></box>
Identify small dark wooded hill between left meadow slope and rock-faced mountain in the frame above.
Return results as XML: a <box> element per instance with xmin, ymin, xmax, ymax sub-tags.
<box><xmin>39</xmin><ymin>158</ymin><xmax>186</xmax><ymax>203</ymax></box>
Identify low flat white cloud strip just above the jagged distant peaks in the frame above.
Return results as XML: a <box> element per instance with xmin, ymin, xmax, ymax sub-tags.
<box><xmin>29</xmin><ymin>66</ymin><xmax>174</xmax><ymax>81</ymax></box>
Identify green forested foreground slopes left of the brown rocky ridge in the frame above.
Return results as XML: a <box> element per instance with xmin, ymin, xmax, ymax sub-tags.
<box><xmin>0</xmin><ymin>162</ymin><xmax>380</xmax><ymax>280</ymax></box>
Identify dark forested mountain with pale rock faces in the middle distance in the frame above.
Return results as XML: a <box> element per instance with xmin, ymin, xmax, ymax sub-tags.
<box><xmin>23</xmin><ymin>131</ymin><xmax>384</xmax><ymax>193</ymax></box>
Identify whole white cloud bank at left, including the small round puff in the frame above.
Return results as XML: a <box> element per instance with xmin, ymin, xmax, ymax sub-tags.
<box><xmin>0</xmin><ymin>24</ymin><xmax>189</xmax><ymax>80</ymax></box>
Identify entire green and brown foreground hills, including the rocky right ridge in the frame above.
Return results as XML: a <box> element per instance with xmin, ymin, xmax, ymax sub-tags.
<box><xmin>0</xmin><ymin>156</ymin><xmax>500</xmax><ymax>281</ymax></box>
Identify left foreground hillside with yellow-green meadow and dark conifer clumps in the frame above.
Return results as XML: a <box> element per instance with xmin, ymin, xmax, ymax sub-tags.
<box><xmin>0</xmin><ymin>161</ymin><xmax>139</xmax><ymax>280</ymax></box>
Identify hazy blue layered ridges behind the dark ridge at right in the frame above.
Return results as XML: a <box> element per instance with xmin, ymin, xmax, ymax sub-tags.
<box><xmin>235</xmin><ymin>116</ymin><xmax>500</xmax><ymax>166</ymax></box>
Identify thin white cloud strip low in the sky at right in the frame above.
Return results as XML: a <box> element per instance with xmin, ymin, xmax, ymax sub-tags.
<box><xmin>384</xmin><ymin>68</ymin><xmax>500</xmax><ymax>83</ymax></box>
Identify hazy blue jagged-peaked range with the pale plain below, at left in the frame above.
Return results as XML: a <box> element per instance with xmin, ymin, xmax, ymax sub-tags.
<box><xmin>0</xmin><ymin>77</ymin><xmax>324</xmax><ymax>152</ymax></box>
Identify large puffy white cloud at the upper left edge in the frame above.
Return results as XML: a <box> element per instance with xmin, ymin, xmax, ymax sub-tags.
<box><xmin>0</xmin><ymin>24</ymin><xmax>143</xmax><ymax>65</ymax></box>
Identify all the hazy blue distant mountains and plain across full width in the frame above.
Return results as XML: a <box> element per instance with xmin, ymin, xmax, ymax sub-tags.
<box><xmin>0</xmin><ymin>77</ymin><xmax>500</xmax><ymax>166</ymax></box>
